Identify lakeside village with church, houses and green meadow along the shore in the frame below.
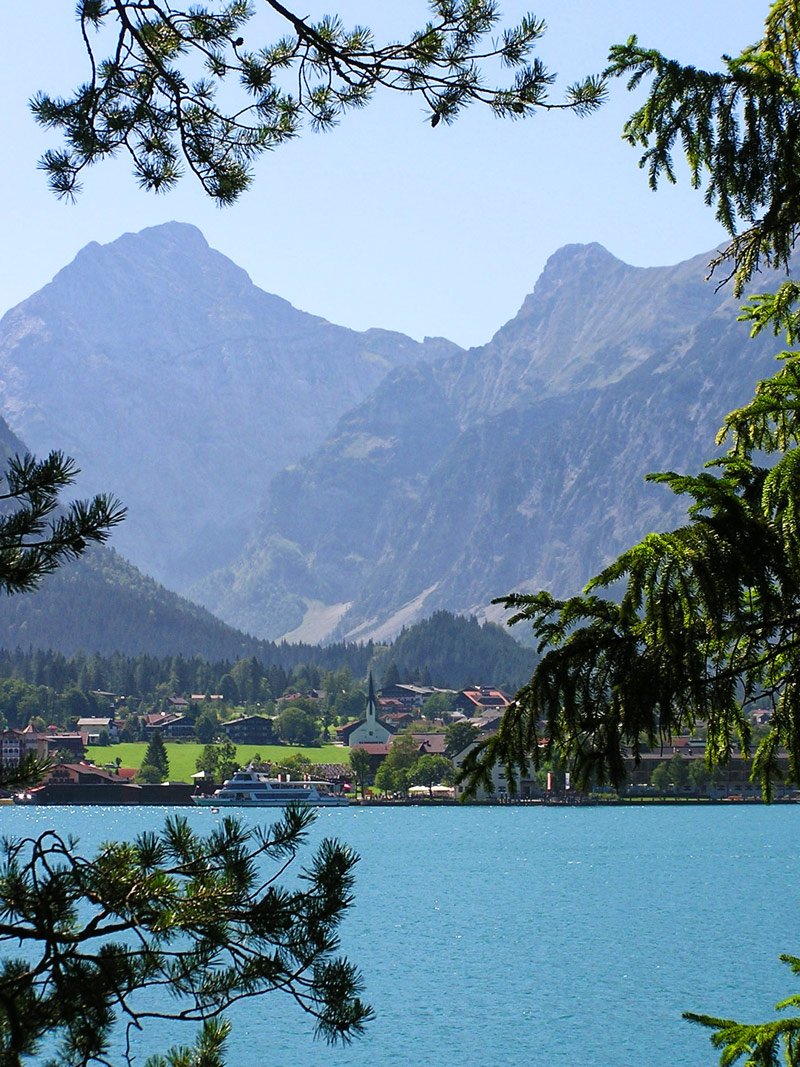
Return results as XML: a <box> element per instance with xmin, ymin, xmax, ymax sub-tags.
<box><xmin>0</xmin><ymin>674</ymin><xmax>796</xmax><ymax>806</ymax></box>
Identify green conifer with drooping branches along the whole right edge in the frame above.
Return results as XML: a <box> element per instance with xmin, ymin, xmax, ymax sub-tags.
<box><xmin>465</xmin><ymin>0</ymin><xmax>800</xmax><ymax>1067</ymax></box>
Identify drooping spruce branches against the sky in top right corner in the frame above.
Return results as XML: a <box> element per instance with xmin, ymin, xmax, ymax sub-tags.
<box><xmin>606</xmin><ymin>0</ymin><xmax>800</xmax><ymax>296</ymax></box>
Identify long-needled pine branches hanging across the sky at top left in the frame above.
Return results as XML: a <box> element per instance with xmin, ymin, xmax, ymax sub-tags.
<box><xmin>31</xmin><ymin>0</ymin><xmax>605</xmax><ymax>204</ymax></box>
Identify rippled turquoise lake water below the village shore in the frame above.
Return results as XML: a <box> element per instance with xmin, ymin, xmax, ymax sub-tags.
<box><xmin>6</xmin><ymin>806</ymin><xmax>800</xmax><ymax>1067</ymax></box>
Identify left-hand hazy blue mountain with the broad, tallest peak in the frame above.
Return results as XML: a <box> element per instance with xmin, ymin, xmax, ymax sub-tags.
<box><xmin>0</xmin><ymin>223</ymin><xmax>459</xmax><ymax>591</ymax></box>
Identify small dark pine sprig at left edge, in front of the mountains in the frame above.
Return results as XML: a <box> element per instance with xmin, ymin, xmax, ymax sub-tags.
<box><xmin>0</xmin><ymin>451</ymin><xmax>125</xmax><ymax>593</ymax></box>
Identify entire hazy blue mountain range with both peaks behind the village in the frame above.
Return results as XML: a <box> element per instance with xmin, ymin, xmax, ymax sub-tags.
<box><xmin>0</xmin><ymin>223</ymin><xmax>789</xmax><ymax>640</ymax></box>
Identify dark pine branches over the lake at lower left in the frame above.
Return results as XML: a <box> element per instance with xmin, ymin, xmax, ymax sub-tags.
<box><xmin>0</xmin><ymin>809</ymin><xmax>371</xmax><ymax>1067</ymax></box>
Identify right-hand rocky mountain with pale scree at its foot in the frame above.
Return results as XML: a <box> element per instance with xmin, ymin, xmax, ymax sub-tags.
<box><xmin>195</xmin><ymin>244</ymin><xmax>793</xmax><ymax>640</ymax></box>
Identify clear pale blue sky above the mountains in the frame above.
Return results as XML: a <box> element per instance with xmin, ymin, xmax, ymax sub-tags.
<box><xmin>0</xmin><ymin>0</ymin><xmax>767</xmax><ymax>347</ymax></box>
